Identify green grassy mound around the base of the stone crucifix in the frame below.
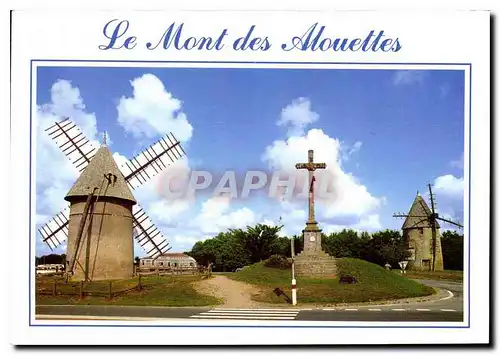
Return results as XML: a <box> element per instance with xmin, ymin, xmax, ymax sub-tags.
<box><xmin>227</xmin><ymin>258</ymin><xmax>433</xmax><ymax>304</ymax></box>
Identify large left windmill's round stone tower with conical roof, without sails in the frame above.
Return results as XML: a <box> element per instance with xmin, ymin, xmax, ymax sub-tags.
<box><xmin>65</xmin><ymin>144</ymin><xmax>136</xmax><ymax>280</ymax></box>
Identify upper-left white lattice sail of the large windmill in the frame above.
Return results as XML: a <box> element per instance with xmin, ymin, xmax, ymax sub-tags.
<box><xmin>46</xmin><ymin>118</ymin><xmax>97</xmax><ymax>172</ymax></box>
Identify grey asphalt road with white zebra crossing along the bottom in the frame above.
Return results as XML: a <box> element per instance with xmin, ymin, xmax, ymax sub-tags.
<box><xmin>36</xmin><ymin>280</ymin><xmax>463</xmax><ymax>322</ymax></box>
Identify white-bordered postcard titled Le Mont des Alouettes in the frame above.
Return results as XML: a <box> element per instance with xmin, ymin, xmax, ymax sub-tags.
<box><xmin>10</xmin><ymin>4</ymin><xmax>490</xmax><ymax>346</ymax></box>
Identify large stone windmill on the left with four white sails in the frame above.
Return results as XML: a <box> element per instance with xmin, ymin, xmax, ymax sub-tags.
<box><xmin>39</xmin><ymin>119</ymin><xmax>185</xmax><ymax>281</ymax></box>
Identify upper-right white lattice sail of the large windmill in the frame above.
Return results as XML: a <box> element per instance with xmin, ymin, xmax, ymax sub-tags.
<box><xmin>120</xmin><ymin>134</ymin><xmax>184</xmax><ymax>189</ymax></box>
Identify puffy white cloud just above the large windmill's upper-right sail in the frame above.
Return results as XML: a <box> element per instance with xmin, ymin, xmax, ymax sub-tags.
<box><xmin>117</xmin><ymin>74</ymin><xmax>193</xmax><ymax>142</ymax></box>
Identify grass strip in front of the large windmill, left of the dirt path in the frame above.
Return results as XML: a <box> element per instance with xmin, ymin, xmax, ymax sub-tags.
<box><xmin>36</xmin><ymin>276</ymin><xmax>220</xmax><ymax>307</ymax></box>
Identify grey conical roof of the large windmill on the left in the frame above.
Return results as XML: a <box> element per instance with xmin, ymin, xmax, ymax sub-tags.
<box><xmin>64</xmin><ymin>145</ymin><xmax>137</xmax><ymax>204</ymax></box>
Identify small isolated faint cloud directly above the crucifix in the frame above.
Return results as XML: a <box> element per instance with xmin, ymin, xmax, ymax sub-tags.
<box><xmin>276</xmin><ymin>97</ymin><xmax>319</xmax><ymax>136</ymax></box>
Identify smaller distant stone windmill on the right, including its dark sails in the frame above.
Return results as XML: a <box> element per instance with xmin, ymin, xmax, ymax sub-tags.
<box><xmin>393</xmin><ymin>184</ymin><xmax>462</xmax><ymax>271</ymax></box>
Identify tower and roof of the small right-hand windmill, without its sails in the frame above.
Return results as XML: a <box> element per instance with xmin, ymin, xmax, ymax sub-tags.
<box><xmin>402</xmin><ymin>193</ymin><xmax>443</xmax><ymax>271</ymax></box>
